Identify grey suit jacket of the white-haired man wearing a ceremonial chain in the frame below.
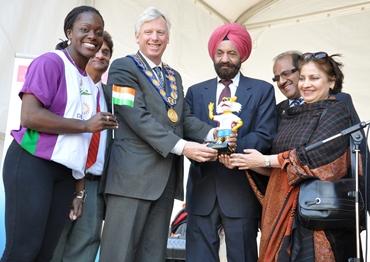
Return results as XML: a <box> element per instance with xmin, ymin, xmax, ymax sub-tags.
<box><xmin>105</xmin><ymin>53</ymin><xmax>211</xmax><ymax>200</ymax></box>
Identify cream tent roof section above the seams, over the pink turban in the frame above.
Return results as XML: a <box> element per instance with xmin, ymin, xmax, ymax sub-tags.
<box><xmin>195</xmin><ymin>0</ymin><xmax>370</xmax><ymax>28</ymax></box>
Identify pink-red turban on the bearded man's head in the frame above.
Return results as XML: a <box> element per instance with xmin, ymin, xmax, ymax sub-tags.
<box><xmin>208</xmin><ymin>23</ymin><xmax>252</xmax><ymax>63</ymax></box>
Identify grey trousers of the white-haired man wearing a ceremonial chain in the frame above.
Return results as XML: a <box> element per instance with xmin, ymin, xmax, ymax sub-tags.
<box><xmin>100</xmin><ymin>163</ymin><xmax>176</xmax><ymax>262</ymax></box>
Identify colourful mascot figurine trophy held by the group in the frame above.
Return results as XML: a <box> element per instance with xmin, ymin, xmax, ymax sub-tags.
<box><xmin>208</xmin><ymin>96</ymin><xmax>243</xmax><ymax>154</ymax></box>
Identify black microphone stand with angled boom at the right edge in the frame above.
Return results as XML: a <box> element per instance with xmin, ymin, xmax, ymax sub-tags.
<box><xmin>305</xmin><ymin>121</ymin><xmax>370</xmax><ymax>262</ymax></box>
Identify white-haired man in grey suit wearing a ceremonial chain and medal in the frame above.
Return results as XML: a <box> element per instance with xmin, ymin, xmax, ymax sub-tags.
<box><xmin>100</xmin><ymin>8</ymin><xmax>217</xmax><ymax>262</ymax></box>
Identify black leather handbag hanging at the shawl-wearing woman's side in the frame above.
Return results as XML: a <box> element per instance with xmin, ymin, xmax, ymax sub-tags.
<box><xmin>297</xmin><ymin>139</ymin><xmax>365</xmax><ymax>230</ymax></box>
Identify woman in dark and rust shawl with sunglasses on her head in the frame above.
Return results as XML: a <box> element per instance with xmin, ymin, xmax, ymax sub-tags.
<box><xmin>220</xmin><ymin>52</ymin><xmax>356</xmax><ymax>262</ymax></box>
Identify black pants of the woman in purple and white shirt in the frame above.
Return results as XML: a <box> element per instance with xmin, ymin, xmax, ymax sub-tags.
<box><xmin>1</xmin><ymin>141</ymin><xmax>75</xmax><ymax>262</ymax></box>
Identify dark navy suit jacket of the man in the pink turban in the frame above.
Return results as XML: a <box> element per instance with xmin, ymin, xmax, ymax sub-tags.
<box><xmin>186</xmin><ymin>75</ymin><xmax>276</xmax><ymax>217</ymax></box>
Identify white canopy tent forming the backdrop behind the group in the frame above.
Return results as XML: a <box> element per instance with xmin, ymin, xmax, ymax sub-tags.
<box><xmin>0</xmin><ymin>0</ymin><xmax>370</xmax><ymax>256</ymax></box>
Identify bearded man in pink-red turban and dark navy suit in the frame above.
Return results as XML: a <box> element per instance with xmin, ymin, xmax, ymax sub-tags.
<box><xmin>186</xmin><ymin>23</ymin><xmax>276</xmax><ymax>262</ymax></box>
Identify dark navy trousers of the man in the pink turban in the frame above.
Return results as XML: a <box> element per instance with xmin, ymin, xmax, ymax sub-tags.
<box><xmin>186</xmin><ymin>201</ymin><xmax>258</xmax><ymax>262</ymax></box>
